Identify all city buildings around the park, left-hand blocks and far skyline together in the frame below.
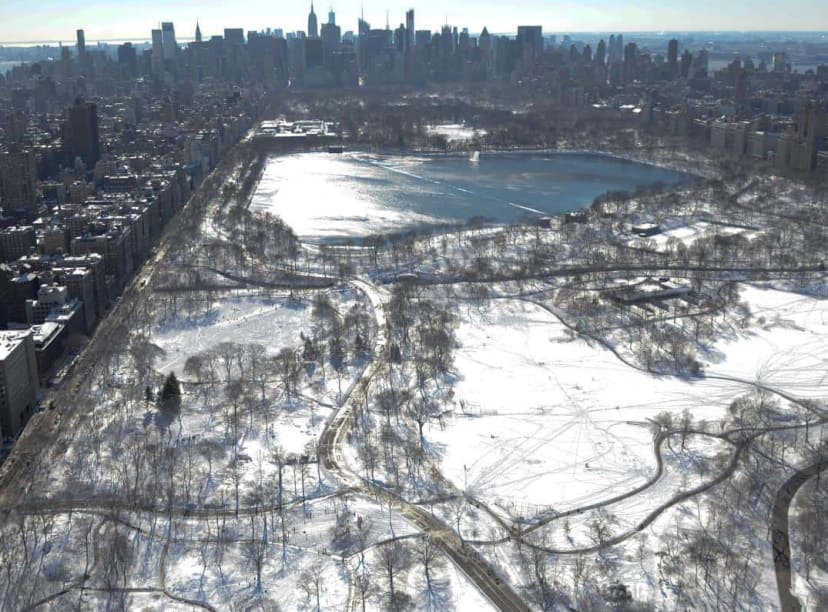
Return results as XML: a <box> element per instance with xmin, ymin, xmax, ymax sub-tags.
<box><xmin>0</xmin><ymin>7</ymin><xmax>828</xmax><ymax>434</ymax></box>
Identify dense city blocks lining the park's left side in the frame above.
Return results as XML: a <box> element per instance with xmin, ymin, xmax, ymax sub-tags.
<box><xmin>0</xmin><ymin>49</ymin><xmax>265</xmax><ymax>438</ymax></box>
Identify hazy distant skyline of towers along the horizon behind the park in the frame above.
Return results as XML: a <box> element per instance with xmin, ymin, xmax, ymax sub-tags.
<box><xmin>40</xmin><ymin>11</ymin><xmax>828</xmax><ymax>172</ymax></box>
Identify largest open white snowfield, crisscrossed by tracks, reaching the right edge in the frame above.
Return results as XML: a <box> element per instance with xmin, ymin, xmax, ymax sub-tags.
<box><xmin>427</xmin><ymin>287</ymin><xmax>828</xmax><ymax>516</ymax></box>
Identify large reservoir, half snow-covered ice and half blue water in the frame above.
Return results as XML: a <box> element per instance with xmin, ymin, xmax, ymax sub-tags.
<box><xmin>252</xmin><ymin>153</ymin><xmax>689</xmax><ymax>242</ymax></box>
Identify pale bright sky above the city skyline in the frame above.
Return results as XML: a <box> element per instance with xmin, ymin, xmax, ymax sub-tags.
<box><xmin>0</xmin><ymin>0</ymin><xmax>828</xmax><ymax>44</ymax></box>
